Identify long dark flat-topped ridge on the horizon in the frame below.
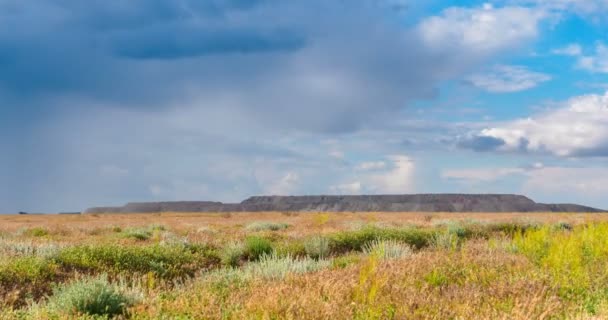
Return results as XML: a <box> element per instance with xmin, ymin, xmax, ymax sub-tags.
<box><xmin>85</xmin><ymin>194</ymin><xmax>605</xmax><ymax>213</ymax></box>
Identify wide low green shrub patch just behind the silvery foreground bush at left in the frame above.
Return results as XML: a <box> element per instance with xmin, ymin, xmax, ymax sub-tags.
<box><xmin>56</xmin><ymin>245</ymin><xmax>219</xmax><ymax>278</ymax></box>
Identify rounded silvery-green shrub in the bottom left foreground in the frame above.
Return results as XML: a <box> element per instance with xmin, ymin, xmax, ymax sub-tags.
<box><xmin>48</xmin><ymin>275</ymin><xmax>136</xmax><ymax>317</ymax></box>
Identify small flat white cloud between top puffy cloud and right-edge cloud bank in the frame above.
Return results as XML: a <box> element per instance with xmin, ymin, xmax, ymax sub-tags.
<box><xmin>467</xmin><ymin>65</ymin><xmax>551</xmax><ymax>93</ymax></box>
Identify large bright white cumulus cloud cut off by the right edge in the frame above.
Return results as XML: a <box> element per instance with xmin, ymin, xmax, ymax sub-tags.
<box><xmin>476</xmin><ymin>92</ymin><xmax>608</xmax><ymax>157</ymax></box>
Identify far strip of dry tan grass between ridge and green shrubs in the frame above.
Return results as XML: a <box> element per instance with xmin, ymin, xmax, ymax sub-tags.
<box><xmin>0</xmin><ymin>212</ymin><xmax>608</xmax><ymax>237</ymax></box>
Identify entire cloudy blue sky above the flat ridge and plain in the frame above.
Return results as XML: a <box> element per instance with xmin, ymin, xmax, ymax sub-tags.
<box><xmin>0</xmin><ymin>0</ymin><xmax>608</xmax><ymax>213</ymax></box>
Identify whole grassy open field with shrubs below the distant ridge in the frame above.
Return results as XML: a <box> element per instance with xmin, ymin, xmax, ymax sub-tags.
<box><xmin>0</xmin><ymin>212</ymin><xmax>608</xmax><ymax>319</ymax></box>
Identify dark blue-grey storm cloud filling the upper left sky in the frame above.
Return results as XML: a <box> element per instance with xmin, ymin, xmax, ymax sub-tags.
<box><xmin>0</xmin><ymin>0</ymin><xmax>455</xmax><ymax>132</ymax></box>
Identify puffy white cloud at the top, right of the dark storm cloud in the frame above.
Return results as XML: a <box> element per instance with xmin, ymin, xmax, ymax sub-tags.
<box><xmin>419</xmin><ymin>4</ymin><xmax>545</xmax><ymax>54</ymax></box>
